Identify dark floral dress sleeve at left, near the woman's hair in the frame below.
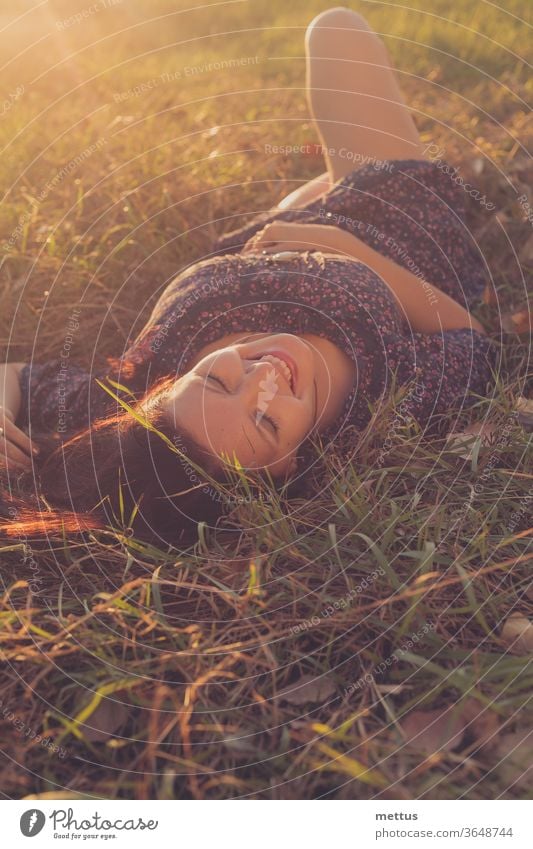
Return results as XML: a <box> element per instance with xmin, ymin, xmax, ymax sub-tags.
<box><xmin>17</xmin><ymin>359</ymin><xmax>100</xmax><ymax>434</ymax></box>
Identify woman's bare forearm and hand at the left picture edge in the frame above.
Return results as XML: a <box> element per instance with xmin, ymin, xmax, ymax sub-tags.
<box><xmin>0</xmin><ymin>363</ymin><xmax>38</xmax><ymax>469</ymax></box>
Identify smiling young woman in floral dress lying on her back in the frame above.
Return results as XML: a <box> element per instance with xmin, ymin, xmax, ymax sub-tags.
<box><xmin>0</xmin><ymin>8</ymin><xmax>495</xmax><ymax>543</ymax></box>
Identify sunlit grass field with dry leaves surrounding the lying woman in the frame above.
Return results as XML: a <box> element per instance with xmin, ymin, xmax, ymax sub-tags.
<box><xmin>0</xmin><ymin>0</ymin><xmax>533</xmax><ymax>799</ymax></box>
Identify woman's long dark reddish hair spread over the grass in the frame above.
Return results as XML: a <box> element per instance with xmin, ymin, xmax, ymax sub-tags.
<box><xmin>0</xmin><ymin>377</ymin><xmax>241</xmax><ymax>544</ymax></box>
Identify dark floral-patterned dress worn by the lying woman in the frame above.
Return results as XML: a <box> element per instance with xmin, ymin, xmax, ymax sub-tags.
<box><xmin>19</xmin><ymin>160</ymin><xmax>496</xmax><ymax>450</ymax></box>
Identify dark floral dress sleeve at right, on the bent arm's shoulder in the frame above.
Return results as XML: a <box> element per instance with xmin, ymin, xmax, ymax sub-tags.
<box><xmin>387</xmin><ymin>327</ymin><xmax>497</xmax><ymax>434</ymax></box>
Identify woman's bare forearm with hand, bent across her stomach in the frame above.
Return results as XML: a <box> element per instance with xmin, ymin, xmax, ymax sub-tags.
<box><xmin>243</xmin><ymin>221</ymin><xmax>486</xmax><ymax>335</ymax></box>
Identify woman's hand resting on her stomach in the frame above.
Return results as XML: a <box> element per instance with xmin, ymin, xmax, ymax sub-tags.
<box><xmin>241</xmin><ymin>221</ymin><xmax>349</xmax><ymax>254</ymax></box>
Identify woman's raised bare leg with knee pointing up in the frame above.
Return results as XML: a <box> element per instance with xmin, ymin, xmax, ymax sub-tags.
<box><xmin>302</xmin><ymin>6</ymin><xmax>426</xmax><ymax>182</ymax></box>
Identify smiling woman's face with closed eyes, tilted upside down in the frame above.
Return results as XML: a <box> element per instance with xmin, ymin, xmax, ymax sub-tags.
<box><xmin>158</xmin><ymin>333</ymin><xmax>317</xmax><ymax>477</ymax></box>
